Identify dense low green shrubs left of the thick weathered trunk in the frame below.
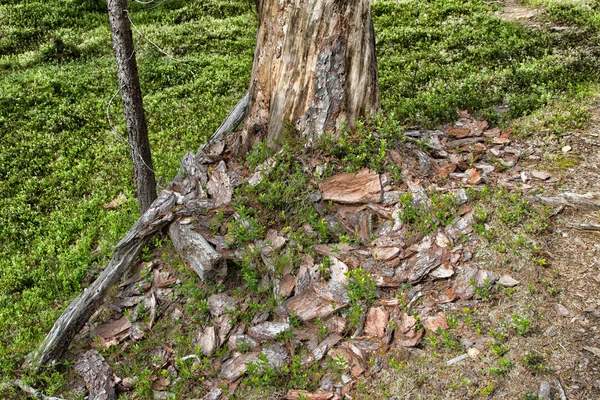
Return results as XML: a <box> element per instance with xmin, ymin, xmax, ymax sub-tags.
<box><xmin>0</xmin><ymin>0</ymin><xmax>255</xmax><ymax>375</ymax></box>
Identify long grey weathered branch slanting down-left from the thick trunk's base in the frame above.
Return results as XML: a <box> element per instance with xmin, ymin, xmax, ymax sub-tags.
<box><xmin>24</xmin><ymin>94</ymin><xmax>248</xmax><ymax>371</ymax></box>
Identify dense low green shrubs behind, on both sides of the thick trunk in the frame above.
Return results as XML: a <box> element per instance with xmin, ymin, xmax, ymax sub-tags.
<box><xmin>0</xmin><ymin>0</ymin><xmax>598</xmax><ymax>390</ymax></box>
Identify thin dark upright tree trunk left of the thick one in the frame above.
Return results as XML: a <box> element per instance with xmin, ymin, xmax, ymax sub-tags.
<box><xmin>108</xmin><ymin>0</ymin><xmax>156</xmax><ymax>214</ymax></box>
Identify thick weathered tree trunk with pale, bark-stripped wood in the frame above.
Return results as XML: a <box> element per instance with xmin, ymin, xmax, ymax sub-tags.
<box><xmin>234</xmin><ymin>0</ymin><xmax>380</xmax><ymax>154</ymax></box>
